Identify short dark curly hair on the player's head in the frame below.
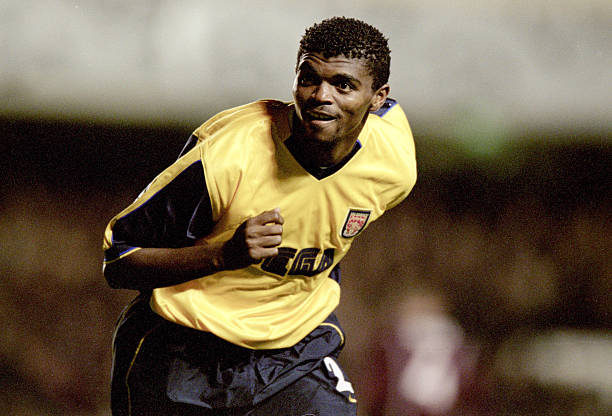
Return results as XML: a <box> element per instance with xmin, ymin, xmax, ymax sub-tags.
<box><xmin>296</xmin><ymin>17</ymin><xmax>391</xmax><ymax>90</ymax></box>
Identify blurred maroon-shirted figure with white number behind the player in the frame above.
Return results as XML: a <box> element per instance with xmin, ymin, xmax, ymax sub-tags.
<box><xmin>363</xmin><ymin>292</ymin><xmax>482</xmax><ymax>416</ymax></box>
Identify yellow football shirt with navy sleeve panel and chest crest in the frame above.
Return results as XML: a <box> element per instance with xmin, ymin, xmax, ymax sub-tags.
<box><xmin>104</xmin><ymin>100</ymin><xmax>416</xmax><ymax>349</ymax></box>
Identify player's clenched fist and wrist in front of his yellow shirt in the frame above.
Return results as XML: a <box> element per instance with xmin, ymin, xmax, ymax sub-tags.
<box><xmin>223</xmin><ymin>208</ymin><xmax>285</xmax><ymax>270</ymax></box>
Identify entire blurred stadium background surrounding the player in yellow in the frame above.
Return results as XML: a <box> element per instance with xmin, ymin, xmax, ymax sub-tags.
<box><xmin>0</xmin><ymin>0</ymin><xmax>612</xmax><ymax>416</ymax></box>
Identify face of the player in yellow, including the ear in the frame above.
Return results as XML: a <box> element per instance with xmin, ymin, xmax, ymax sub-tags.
<box><xmin>293</xmin><ymin>53</ymin><xmax>389</xmax><ymax>148</ymax></box>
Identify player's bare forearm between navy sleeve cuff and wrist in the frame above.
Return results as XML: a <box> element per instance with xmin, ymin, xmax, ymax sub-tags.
<box><xmin>104</xmin><ymin>245</ymin><xmax>223</xmax><ymax>290</ymax></box>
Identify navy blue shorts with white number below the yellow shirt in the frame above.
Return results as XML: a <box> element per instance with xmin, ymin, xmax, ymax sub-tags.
<box><xmin>111</xmin><ymin>295</ymin><xmax>357</xmax><ymax>416</ymax></box>
